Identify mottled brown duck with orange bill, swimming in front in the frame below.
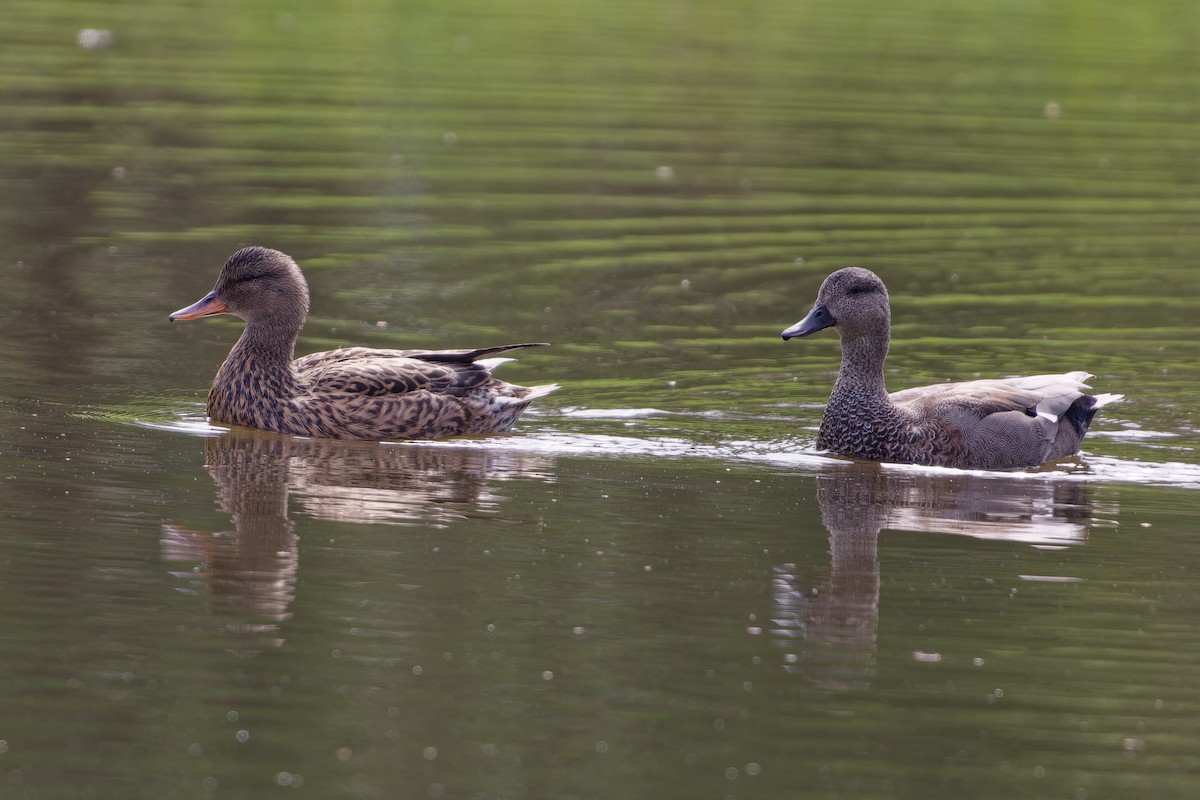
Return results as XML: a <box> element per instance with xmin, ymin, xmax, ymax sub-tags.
<box><xmin>168</xmin><ymin>247</ymin><xmax>558</xmax><ymax>439</ymax></box>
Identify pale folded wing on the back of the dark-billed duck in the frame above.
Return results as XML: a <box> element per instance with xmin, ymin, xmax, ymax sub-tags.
<box><xmin>889</xmin><ymin>372</ymin><xmax>1092</xmax><ymax>420</ymax></box>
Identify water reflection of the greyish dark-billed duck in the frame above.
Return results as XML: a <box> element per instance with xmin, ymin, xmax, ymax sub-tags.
<box><xmin>772</xmin><ymin>464</ymin><xmax>1108</xmax><ymax>690</ymax></box>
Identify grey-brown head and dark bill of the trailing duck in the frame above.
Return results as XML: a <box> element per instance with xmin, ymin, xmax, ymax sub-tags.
<box><xmin>782</xmin><ymin>266</ymin><xmax>892</xmax><ymax>339</ymax></box>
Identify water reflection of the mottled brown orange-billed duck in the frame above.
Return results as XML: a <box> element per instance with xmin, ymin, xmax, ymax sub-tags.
<box><xmin>161</xmin><ymin>429</ymin><xmax>552</xmax><ymax>654</ymax></box>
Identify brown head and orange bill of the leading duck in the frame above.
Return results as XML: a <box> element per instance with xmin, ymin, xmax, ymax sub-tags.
<box><xmin>168</xmin><ymin>247</ymin><xmax>308</xmax><ymax>327</ymax></box>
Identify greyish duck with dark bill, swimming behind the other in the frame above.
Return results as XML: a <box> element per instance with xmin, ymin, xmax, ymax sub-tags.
<box><xmin>782</xmin><ymin>266</ymin><xmax>1123</xmax><ymax>469</ymax></box>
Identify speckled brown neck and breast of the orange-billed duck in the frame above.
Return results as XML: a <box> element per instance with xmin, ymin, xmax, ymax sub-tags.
<box><xmin>209</xmin><ymin>321</ymin><xmax>300</xmax><ymax>432</ymax></box>
